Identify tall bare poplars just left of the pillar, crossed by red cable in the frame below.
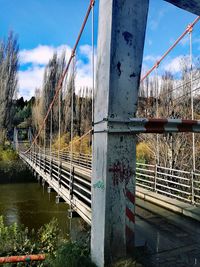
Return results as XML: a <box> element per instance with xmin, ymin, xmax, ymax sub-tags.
<box><xmin>32</xmin><ymin>53</ymin><xmax>92</xmax><ymax>147</ymax></box>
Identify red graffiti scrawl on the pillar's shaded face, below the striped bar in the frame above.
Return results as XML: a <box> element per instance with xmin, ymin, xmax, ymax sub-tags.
<box><xmin>109</xmin><ymin>161</ymin><xmax>133</xmax><ymax>186</ymax></box>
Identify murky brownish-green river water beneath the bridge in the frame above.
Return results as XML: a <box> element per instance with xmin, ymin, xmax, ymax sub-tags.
<box><xmin>0</xmin><ymin>165</ymin><xmax>81</xmax><ymax>237</ymax></box>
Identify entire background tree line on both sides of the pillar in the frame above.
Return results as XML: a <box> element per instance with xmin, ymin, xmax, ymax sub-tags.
<box><xmin>0</xmin><ymin>32</ymin><xmax>200</xmax><ymax>170</ymax></box>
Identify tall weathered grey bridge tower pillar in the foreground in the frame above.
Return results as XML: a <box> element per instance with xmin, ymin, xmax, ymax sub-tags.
<box><xmin>91</xmin><ymin>0</ymin><xmax>149</xmax><ymax>267</ymax></box>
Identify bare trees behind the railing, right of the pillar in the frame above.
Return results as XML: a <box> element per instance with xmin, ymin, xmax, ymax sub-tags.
<box><xmin>137</xmin><ymin>58</ymin><xmax>200</xmax><ymax>171</ymax></box>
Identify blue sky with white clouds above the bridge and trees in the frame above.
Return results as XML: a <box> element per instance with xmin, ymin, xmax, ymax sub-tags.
<box><xmin>0</xmin><ymin>0</ymin><xmax>200</xmax><ymax>99</ymax></box>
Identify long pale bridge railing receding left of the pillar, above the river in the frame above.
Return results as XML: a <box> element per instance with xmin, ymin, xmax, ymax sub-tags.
<box><xmin>21</xmin><ymin>151</ymin><xmax>91</xmax><ymax>211</ymax></box>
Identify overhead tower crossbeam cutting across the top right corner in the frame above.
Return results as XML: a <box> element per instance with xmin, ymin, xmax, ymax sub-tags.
<box><xmin>164</xmin><ymin>0</ymin><xmax>200</xmax><ymax>16</ymax></box>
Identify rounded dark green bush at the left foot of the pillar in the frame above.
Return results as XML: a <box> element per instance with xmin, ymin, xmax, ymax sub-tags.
<box><xmin>48</xmin><ymin>241</ymin><xmax>96</xmax><ymax>267</ymax></box>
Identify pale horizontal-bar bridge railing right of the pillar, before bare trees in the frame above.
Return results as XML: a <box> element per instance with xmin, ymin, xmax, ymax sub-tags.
<box><xmin>136</xmin><ymin>163</ymin><xmax>200</xmax><ymax>205</ymax></box>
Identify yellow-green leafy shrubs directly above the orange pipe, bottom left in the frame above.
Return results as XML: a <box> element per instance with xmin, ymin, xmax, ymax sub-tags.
<box><xmin>0</xmin><ymin>216</ymin><xmax>60</xmax><ymax>256</ymax></box>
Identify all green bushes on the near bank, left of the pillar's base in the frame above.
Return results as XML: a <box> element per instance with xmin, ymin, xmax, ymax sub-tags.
<box><xmin>0</xmin><ymin>216</ymin><xmax>95</xmax><ymax>267</ymax></box>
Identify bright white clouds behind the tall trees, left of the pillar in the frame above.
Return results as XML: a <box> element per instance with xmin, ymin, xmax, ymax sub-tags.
<box><xmin>19</xmin><ymin>45</ymin><xmax>96</xmax><ymax>99</ymax></box>
